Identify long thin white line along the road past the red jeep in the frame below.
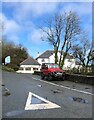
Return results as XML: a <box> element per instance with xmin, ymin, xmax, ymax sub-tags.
<box><xmin>32</xmin><ymin>77</ymin><xmax>94</xmax><ymax>95</ymax></box>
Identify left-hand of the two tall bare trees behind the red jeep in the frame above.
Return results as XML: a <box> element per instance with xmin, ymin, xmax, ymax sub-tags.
<box><xmin>41</xmin><ymin>14</ymin><xmax>63</xmax><ymax>64</ymax></box>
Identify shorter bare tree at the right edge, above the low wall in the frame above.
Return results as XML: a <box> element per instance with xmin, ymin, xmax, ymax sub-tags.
<box><xmin>72</xmin><ymin>36</ymin><xmax>94</xmax><ymax>72</ymax></box>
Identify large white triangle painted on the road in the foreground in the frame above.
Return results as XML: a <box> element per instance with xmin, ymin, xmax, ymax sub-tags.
<box><xmin>25</xmin><ymin>92</ymin><xmax>61</xmax><ymax>110</ymax></box>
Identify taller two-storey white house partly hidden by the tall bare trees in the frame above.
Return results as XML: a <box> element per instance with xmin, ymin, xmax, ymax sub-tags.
<box><xmin>36</xmin><ymin>50</ymin><xmax>80</xmax><ymax>70</ymax></box>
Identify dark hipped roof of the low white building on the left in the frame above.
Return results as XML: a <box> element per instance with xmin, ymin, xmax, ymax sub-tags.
<box><xmin>20</xmin><ymin>57</ymin><xmax>40</xmax><ymax>65</ymax></box>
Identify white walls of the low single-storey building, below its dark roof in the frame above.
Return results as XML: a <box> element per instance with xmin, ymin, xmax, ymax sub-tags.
<box><xmin>16</xmin><ymin>65</ymin><xmax>41</xmax><ymax>73</ymax></box>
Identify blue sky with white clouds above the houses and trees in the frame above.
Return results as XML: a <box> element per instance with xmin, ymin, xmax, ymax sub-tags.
<box><xmin>0</xmin><ymin>2</ymin><xmax>92</xmax><ymax>58</ymax></box>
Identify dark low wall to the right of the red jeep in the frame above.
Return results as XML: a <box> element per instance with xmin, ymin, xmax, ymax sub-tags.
<box><xmin>66</xmin><ymin>74</ymin><xmax>94</xmax><ymax>85</ymax></box>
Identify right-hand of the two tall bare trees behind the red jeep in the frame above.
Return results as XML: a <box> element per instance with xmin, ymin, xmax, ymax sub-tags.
<box><xmin>59</xmin><ymin>12</ymin><xmax>80</xmax><ymax>68</ymax></box>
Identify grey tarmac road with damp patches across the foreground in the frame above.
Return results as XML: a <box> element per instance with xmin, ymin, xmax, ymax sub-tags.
<box><xmin>2</xmin><ymin>72</ymin><xmax>94</xmax><ymax>118</ymax></box>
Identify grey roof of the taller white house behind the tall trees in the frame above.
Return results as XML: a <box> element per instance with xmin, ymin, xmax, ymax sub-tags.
<box><xmin>36</xmin><ymin>50</ymin><xmax>73</xmax><ymax>59</ymax></box>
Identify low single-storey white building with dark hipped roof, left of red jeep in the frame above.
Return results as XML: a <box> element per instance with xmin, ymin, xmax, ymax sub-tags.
<box><xmin>16</xmin><ymin>57</ymin><xmax>41</xmax><ymax>73</ymax></box>
